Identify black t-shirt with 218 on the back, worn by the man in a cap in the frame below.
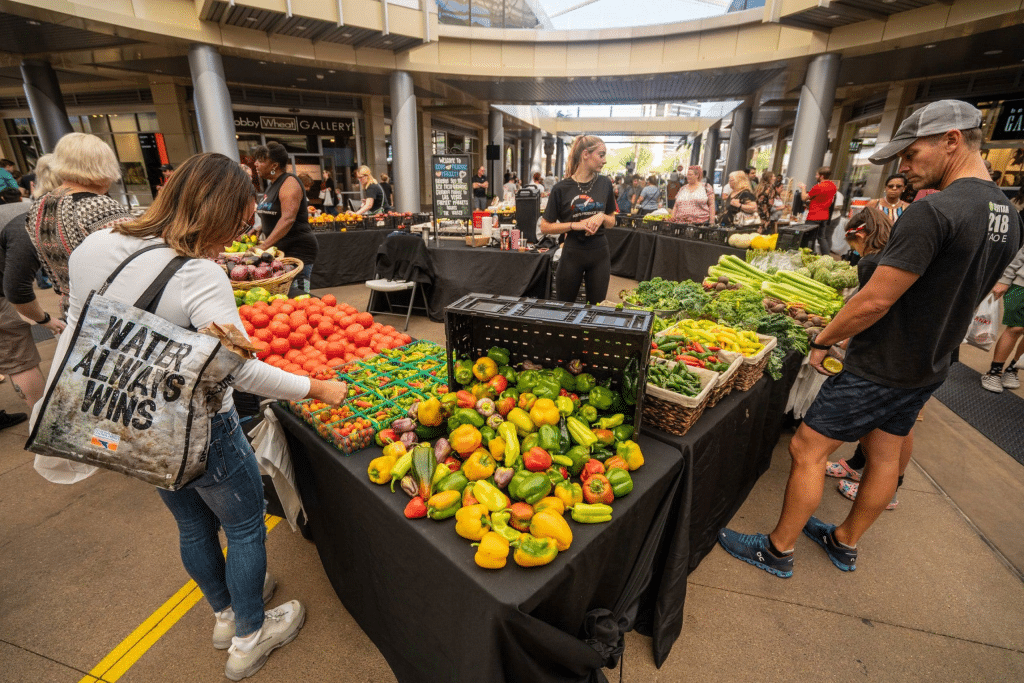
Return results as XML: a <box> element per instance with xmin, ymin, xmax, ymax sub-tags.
<box><xmin>845</xmin><ymin>178</ymin><xmax>1021</xmax><ymax>389</ymax></box>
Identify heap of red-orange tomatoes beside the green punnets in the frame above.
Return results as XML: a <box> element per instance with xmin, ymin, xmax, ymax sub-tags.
<box><xmin>239</xmin><ymin>294</ymin><xmax>412</xmax><ymax>380</ymax></box>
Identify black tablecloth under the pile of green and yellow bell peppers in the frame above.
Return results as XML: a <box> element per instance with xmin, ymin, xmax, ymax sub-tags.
<box><xmin>273</xmin><ymin>405</ymin><xmax>683</xmax><ymax>683</ymax></box>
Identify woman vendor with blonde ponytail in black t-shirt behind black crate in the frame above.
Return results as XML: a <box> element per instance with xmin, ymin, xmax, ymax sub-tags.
<box><xmin>541</xmin><ymin>135</ymin><xmax>615</xmax><ymax>304</ymax></box>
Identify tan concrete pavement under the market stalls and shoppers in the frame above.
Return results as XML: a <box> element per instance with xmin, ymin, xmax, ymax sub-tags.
<box><xmin>0</xmin><ymin>278</ymin><xmax>1024</xmax><ymax>683</ymax></box>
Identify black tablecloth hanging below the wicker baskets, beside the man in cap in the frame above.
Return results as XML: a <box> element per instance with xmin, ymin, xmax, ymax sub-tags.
<box><xmin>637</xmin><ymin>352</ymin><xmax>802</xmax><ymax>667</ymax></box>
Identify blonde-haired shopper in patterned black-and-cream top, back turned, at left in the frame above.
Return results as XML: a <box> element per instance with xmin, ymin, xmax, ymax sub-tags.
<box><xmin>28</xmin><ymin>133</ymin><xmax>132</xmax><ymax>317</ymax></box>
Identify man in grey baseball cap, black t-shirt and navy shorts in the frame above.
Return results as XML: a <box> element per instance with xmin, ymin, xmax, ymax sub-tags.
<box><xmin>719</xmin><ymin>99</ymin><xmax>1021</xmax><ymax>578</ymax></box>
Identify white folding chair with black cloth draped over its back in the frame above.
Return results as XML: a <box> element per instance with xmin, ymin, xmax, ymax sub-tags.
<box><xmin>367</xmin><ymin>234</ymin><xmax>434</xmax><ymax>331</ymax></box>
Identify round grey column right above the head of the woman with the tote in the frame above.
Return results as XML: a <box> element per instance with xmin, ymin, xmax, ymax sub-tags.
<box><xmin>188</xmin><ymin>43</ymin><xmax>239</xmax><ymax>161</ymax></box>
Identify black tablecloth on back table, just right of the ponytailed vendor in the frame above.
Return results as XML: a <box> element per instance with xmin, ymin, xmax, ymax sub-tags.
<box><xmin>608</xmin><ymin>227</ymin><xmax>746</xmax><ymax>283</ymax></box>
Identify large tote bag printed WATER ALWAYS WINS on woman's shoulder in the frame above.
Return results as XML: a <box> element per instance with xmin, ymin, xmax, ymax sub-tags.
<box><xmin>25</xmin><ymin>244</ymin><xmax>244</xmax><ymax>490</ymax></box>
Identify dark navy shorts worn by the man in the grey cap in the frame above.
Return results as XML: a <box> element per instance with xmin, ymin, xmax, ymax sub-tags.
<box><xmin>804</xmin><ymin>372</ymin><xmax>942</xmax><ymax>441</ymax></box>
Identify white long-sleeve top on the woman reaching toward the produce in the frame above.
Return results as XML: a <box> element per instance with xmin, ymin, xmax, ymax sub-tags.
<box><xmin>47</xmin><ymin>229</ymin><xmax>309</xmax><ymax>413</ymax></box>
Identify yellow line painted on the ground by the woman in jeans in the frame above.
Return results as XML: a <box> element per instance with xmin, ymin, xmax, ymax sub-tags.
<box><xmin>78</xmin><ymin>515</ymin><xmax>281</xmax><ymax>683</ymax></box>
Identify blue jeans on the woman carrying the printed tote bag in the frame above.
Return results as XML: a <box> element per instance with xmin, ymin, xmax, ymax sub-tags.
<box><xmin>158</xmin><ymin>408</ymin><xmax>266</xmax><ymax>636</ymax></box>
